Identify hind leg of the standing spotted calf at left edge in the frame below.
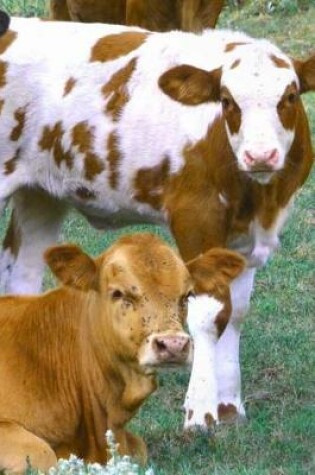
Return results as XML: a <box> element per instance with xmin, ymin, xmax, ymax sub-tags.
<box><xmin>0</xmin><ymin>188</ymin><xmax>66</xmax><ymax>294</ymax></box>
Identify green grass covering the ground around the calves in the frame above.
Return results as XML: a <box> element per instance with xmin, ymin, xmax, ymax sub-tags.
<box><xmin>0</xmin><ymin>0</ymin><xmax>315</xmax><ymax>475</ymax></box>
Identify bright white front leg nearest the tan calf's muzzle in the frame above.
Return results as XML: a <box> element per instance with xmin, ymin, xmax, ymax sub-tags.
<box><xmin>184</xmin><ymin>295</ymin><xmax>222</xmax><ymax>430</ymax></box>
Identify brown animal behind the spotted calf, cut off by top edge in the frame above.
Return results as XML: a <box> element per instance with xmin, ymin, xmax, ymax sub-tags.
<box><xmin>50</xmin><ymin>0</ymin><xmax>224</xmax><ymax>32</ymax></box>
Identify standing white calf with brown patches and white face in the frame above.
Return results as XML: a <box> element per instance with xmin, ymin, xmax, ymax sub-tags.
<box><xmin>0</xmin><ymin>19</ymin><xmax>315</xmax><ymax>427</ymax></box>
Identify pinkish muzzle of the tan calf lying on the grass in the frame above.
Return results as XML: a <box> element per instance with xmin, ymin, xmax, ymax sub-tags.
<box><xmin>152</xmin><ymin>335</ymin><xmax>190</xmax><ymax>362</ymax></box>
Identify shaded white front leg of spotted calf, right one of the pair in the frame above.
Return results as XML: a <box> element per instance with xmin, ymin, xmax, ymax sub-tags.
<box><xmin>216</xmin><ymin>268</ymin><xmax>255</xmax><ymax>422</ymax></box>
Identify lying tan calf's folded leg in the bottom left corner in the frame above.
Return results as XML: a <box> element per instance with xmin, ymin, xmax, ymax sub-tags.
<box><xmin>0</xmin><ymin>420</ymin><xmax>57</xmax><ymax>474</ymax></box>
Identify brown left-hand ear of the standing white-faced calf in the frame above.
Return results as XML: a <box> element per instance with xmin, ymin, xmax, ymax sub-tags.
<box><xmin>159</xmin><ymin>64</ymin><xmax>222</xmax><ymax>106</ymax></box>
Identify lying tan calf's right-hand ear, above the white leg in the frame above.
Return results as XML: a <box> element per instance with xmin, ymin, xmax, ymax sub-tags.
<box><xmin>186</xmin><ymin>248</ymin><xmax>245</xmax><ymax>295</ymax></box>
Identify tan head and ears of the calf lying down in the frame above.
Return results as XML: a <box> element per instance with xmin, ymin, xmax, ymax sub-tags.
<box><xmin>45</xmin><ymin>234</ymin><xmax>244</xmax><ymax>373</ymax></box>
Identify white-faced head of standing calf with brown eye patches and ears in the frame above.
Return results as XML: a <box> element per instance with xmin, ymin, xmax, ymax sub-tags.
<box><xmin>159</xmin><ymin>38</ymin><xmax>315</xmax><ymax>183</ymax></box>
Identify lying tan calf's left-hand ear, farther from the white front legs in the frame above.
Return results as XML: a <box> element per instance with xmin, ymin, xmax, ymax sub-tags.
<box><xmin>44</xmin><ymin>244</ymin><xmax>98</xmax><ymax>291</ymax></box>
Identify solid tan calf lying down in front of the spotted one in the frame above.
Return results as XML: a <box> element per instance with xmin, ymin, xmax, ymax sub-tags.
<box><xmin>0</xmin><ymin>234</ymin><xmax>244</xmax><ymax>472</ymax></box>
